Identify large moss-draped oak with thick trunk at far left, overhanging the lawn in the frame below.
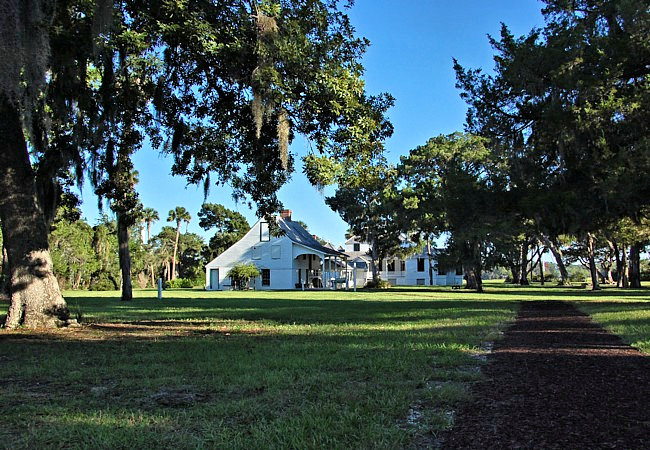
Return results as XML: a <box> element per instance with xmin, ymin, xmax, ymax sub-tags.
<box><xmin>0</xmin><ymin>0</ymin><xmax>390</xmax><ymax>326</ymax></box>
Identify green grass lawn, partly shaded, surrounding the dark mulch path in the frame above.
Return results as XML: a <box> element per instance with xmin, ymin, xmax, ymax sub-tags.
<box><xmin>0</xmin><ymin>284</ymin><xmax>650</xmax><ymax>448</ymax></box>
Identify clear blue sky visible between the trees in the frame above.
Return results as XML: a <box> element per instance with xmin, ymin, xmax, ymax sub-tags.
<box><xmin>74</xmin><ymin>0</ymin><xmax>543</xmax><ymax>244</ymax></box>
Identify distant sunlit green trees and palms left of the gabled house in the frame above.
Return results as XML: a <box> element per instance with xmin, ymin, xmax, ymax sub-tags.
<box><xmin>0</xmin><ymin>203</ymin><xmax>250</xmax><ymax>290</ymax></box>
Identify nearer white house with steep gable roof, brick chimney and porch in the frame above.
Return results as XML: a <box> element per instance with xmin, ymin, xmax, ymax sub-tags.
<box><xmin>205</xmin><ymin>210</ymin><xmax>349</xmax><ymax>290</ymax></box>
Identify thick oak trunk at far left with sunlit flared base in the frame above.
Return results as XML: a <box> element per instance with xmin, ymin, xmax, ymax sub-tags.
<box><xmin>0</xmin><ymin>96</ymin><xmax>70</xmax><ymax>328</ymax></box>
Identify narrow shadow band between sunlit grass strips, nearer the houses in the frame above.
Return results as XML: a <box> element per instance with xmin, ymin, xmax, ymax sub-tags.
<box><xmin>66</xmin><ymin>297</ymin><xmax>516</xmax><ymax>325</ymax></box>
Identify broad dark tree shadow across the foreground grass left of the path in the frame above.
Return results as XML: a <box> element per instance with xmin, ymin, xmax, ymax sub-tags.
<box><xmin>0</xmin><ymin>321</ymin><xmax>490</xmax><ymax>448</ymax></box>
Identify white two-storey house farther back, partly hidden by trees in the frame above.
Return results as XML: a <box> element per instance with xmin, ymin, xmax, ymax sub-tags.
<box><xmin>345</xmin><ymin>236</ymin><xmax>463</xmax><ymax>286</ymax></box>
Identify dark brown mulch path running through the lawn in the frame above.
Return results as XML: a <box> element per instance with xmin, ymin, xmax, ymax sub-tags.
<box><xmin>442</xmin><ymin>301</ymin><xmax>650</xmax><ymax>449</ymax></box>
